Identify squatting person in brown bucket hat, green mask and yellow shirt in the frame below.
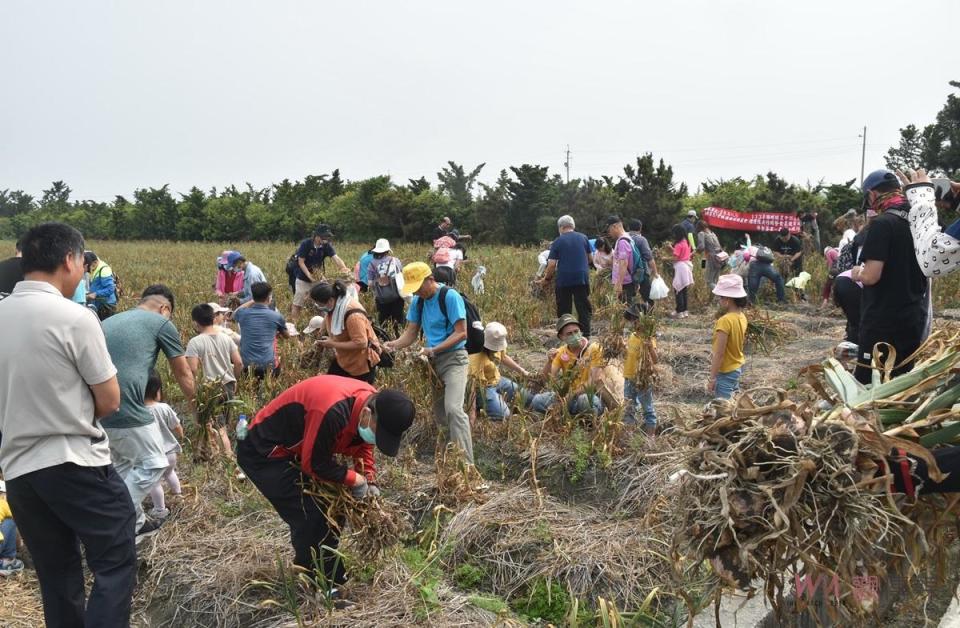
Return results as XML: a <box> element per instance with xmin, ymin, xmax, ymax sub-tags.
<box><xmin>530</xmin><ymin>314</ymin><xmax>603</xmax><ymax>414</ymax></box>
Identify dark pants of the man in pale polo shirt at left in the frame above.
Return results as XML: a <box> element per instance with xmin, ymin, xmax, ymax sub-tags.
<box><xmin>7</xmin><ymin>463</ymin><xmax>137</xmax><ymax>628</ymax></box>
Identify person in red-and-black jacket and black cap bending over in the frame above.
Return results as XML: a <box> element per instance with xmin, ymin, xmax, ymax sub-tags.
<box><xmin>237</xmin><ymin>375</ymin><xmax>416</xmax><ymax>597</ymax></box>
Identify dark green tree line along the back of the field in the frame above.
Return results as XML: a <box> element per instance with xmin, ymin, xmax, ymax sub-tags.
<box><xmin>0</xmin><ymin>82</ymin><xmax>960</xmax><ymax>250</ymax></box>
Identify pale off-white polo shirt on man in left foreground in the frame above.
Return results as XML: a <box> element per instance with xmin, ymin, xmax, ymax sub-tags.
<box><xmin>0</xmin><ymin>281</ymin><xmax>117</xmax><ymax>480</ymax></box>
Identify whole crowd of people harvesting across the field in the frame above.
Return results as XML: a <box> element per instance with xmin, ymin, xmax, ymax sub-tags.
<box><xmin>0</xmin><ymin>171</ymin><xmax>960</xmax><ymax>626</ymax></box>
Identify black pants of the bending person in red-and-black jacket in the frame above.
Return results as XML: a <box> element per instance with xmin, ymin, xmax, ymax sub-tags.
<box><xmin>237</xmin><ymin>440</ymin><xmax>347</xmax><ymax>585</ymax></box>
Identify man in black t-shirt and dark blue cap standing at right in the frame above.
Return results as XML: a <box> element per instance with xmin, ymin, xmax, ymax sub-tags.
<box><xmin>851</xmin><ymin>170</ymin><xmax>928</xmax><ymax>384</ymax></box>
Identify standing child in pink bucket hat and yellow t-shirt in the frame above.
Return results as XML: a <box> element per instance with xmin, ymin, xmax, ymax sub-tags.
<box><xmin>707</xmin><ymin>273</ymin><xmax>747</xmax><ymax>399</ymax></box>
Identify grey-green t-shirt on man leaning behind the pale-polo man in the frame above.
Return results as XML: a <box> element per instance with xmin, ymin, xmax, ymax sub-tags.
<box><xmin>102</xmin><ymin>308</ymin><xmax>183</xmax><ymax>428</ymax></box>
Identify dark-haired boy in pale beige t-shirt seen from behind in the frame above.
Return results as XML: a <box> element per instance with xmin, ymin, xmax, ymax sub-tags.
<box><xmin>185</xmin><ymin>303</ymin><xmax>243</xmax><ymax>458</ymax></box>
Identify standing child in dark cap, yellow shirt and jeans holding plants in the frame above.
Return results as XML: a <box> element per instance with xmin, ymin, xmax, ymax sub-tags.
<box><xmin>623</xmin><ymin>304</ymin><xmax>657</xmax><ymax>438</ymax></box>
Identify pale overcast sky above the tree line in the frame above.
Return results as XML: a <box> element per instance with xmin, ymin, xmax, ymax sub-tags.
<box><xmin>0</xmin><ymin>0</ymin><xmax>960</xmax><ymax>200</ymax></box>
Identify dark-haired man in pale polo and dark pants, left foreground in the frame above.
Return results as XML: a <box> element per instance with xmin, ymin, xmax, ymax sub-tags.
<box><xmin>0</xmin><ymin>223</ymin><xmax>137</xmax><ymax>626</ymax></box>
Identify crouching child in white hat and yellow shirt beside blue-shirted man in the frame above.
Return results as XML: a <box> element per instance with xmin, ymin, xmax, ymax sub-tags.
<box><xmin>470</xmin><ymin>323</ymin><xmax>530</xmax><ymax>421</ymax></box>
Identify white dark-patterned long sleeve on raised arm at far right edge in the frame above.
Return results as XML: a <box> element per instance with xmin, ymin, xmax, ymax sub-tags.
<box><xmin>905</xmin><ymin>183</ymin><xmax>960</xmax><ymax>277</ymax></box>
